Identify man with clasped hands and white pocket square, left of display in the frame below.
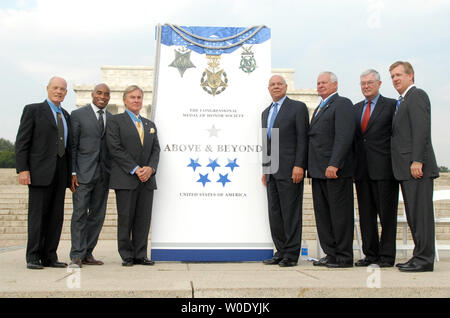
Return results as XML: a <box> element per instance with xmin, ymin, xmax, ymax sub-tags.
<box><xmin>106</xmin><ymin>85</ymin><xmax>160</xmax><ymax>266</ymax></box>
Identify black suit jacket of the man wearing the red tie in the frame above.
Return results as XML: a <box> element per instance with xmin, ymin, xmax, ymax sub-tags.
<box><xmin>355</xmin><ymin>95</ymin><xmax>397</xmax><ymax>180</ymax></box>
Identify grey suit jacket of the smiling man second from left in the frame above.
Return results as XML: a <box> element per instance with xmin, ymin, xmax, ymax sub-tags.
<box><xmin>70</xmin><ymin>105</ymin><xmax>112</xmax><ymax>183</ymax></box>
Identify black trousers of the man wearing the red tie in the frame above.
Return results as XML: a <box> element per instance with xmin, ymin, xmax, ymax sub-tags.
<box><xmin>355</xmin><ymin>180</ymin><xmax>398</xmax><ymax>264</ymax></box>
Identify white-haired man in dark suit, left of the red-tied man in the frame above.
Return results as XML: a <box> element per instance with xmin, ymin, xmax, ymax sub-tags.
<box><xmin>308</xmin><ymin>72</ymin><xmax>355</xmax><ymax>268</ymax></box>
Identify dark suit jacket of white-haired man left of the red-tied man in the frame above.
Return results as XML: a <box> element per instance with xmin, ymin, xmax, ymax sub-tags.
<box><xmin>308</xmin><ymin>94</ymin><xmax>355</xmax><ymax>179</ymax></box>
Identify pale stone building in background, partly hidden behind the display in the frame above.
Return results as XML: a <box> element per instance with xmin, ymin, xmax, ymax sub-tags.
<box><xmin>73</xmin><ymin>65</ymin><xmax>319</xmax><ymax>118</ymax></box>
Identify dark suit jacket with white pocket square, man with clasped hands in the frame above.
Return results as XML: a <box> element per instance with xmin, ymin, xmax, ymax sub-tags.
<box><xmin>106</xmin><ymin>112</ymin><xmax>160</xmax><ymax>190</ymax></box>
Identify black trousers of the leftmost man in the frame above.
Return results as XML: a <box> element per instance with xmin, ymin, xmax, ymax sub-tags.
<box><xmin>26</xmin><ymin>156</ymin><xmax>67</xmax><ymax>264</ymax></box>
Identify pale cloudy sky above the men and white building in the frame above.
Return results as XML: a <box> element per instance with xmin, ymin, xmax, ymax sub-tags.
<box><xmin>0</xmin><ymin>0</ymin><xmax>450</xmax><ymax>166</ymax></box>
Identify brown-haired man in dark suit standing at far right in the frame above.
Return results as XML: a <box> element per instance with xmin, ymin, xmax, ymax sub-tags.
<box><xmin>389</xmin><ymin>61</ymin><xmax>439</xmax><ymax>272</ymax></box>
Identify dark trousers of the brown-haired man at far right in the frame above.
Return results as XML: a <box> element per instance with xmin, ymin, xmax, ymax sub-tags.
<box><xmin>400</xmin><ymin>178</ymin><xmax>435</xmax><ymax>264</ymax></box>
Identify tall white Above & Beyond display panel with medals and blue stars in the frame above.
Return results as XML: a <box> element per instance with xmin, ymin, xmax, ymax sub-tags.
<box><xmin>151</xmin><ymin>24</ymin><xmax>273</xmax><ymax>261</ymax></box>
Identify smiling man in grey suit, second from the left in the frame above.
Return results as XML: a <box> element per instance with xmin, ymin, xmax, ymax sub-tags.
<box><xmin>69</xmin><ymin>84</ymin><xmax>112</xmax><ymax>267</ymax></box>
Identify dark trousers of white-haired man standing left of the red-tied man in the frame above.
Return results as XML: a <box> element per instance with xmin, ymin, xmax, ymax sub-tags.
<box><xmin>312</xmin><ymin>178</ymin><xmax>354</xmax><ymax>264</ymax></box>
